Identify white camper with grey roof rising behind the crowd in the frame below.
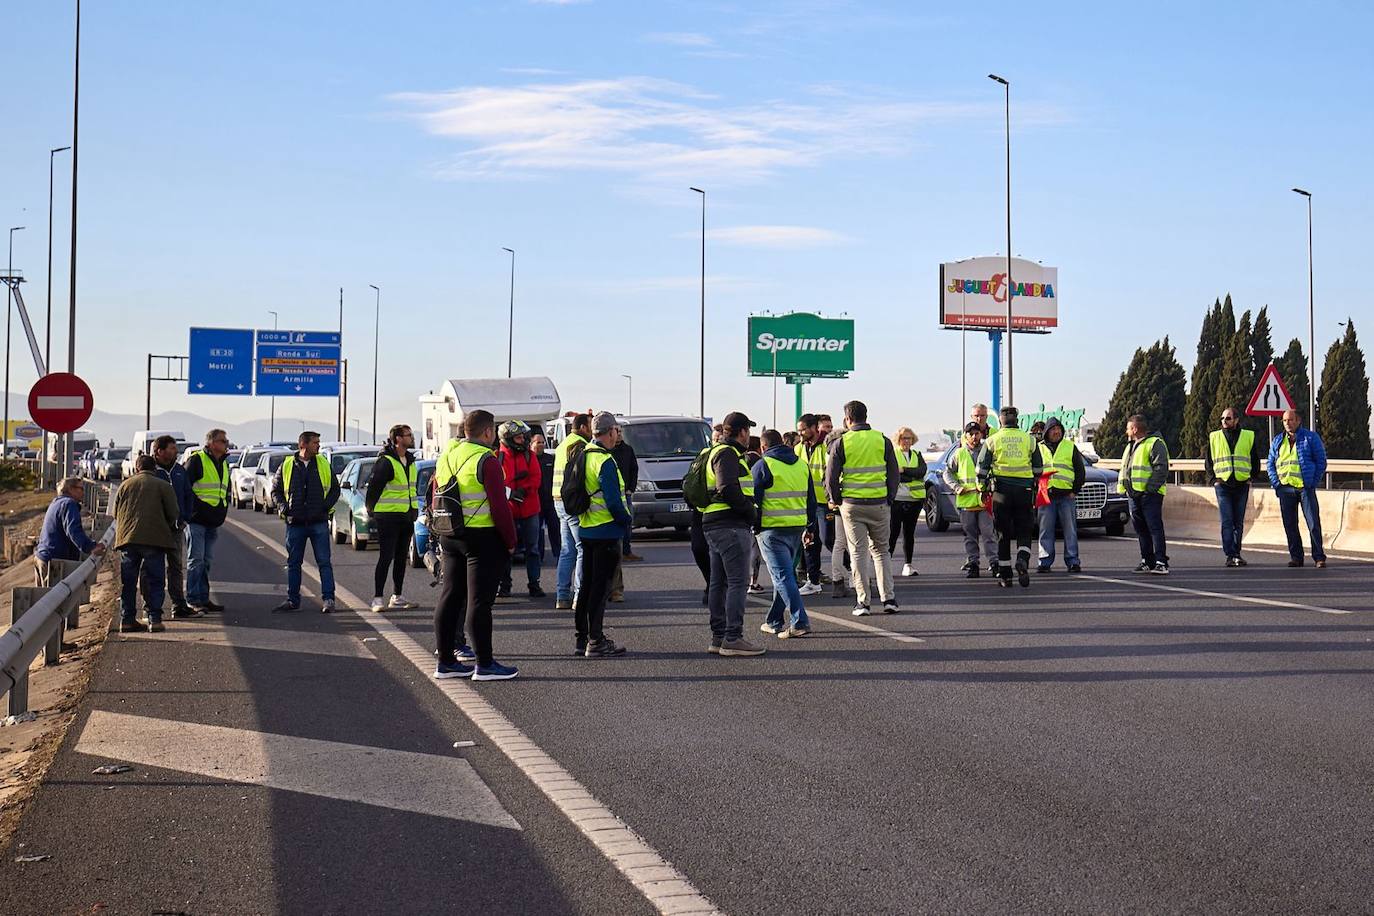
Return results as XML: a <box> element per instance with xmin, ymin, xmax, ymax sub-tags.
<box><xmin>419</xmin><ymin>375</ymin><xmax>562</xmax><ymax>459</ymax></box>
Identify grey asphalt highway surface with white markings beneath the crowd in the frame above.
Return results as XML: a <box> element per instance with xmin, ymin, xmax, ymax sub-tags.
<box><xmin>0</xmin><ymin>511</ymin><xmax>1374</xmax><ymax>915</ymax></box>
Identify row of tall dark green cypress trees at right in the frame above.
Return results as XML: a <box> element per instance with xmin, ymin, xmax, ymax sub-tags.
<box><xmin>1094</xmin><ymin>295</ymin><xmax>1371</xmax><ymax>459</ymax></box>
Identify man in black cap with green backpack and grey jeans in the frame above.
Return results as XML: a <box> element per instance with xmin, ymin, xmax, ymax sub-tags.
<box><xmin>701</xmin><ymin>411</ymin><xmax>764</xmax><ymax>656</ymax></box>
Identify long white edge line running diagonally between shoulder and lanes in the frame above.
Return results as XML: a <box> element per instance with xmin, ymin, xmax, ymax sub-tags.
<box><xmin>228</xmin><ymin>518</ymin><xmax>720</xmax><ymax>916</ymax></box>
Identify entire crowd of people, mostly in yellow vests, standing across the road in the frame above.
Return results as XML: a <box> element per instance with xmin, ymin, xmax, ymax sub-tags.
<box><xmin>34</xmin><ymin>401</ymin><xmax>1327</xmax><ymax>680</ymax></box>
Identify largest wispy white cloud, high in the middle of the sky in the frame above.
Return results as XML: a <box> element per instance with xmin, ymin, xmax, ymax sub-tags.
<box><xmin>393</xmin><ymin>77</ymin><xmax>1033</xmax><ymax>184</ymax></box>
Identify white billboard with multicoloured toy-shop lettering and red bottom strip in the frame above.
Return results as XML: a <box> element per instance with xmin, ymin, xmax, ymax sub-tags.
<box><xmin>940</xmin><ymin>258</ymin><xmax>1059</xmax><ymax>332</ymax></box>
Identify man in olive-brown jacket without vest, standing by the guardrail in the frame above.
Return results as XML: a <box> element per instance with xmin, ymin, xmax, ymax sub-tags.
<box><xmin>114</xmin><ymin>455</ymin><xmax>177</xmax><ymax>633</ymax></box>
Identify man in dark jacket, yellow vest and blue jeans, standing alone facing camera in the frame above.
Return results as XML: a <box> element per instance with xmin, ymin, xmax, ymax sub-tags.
<box><xmin>272</xmin><ymin>431</ymin><xmax>339</xmax><ymax>614</ymax></box>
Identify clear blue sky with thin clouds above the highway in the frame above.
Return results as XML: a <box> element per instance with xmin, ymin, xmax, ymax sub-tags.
<box><xmin>0</xmin><ymin>0</ymin><xmax>1374</xmax><ymax>439</ymax></box>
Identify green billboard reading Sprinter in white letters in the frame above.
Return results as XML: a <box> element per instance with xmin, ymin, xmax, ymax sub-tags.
<box><xmin>749</xmin><ymin>312</ymin><xmax>855</xmax><ymax>379</ymax></box>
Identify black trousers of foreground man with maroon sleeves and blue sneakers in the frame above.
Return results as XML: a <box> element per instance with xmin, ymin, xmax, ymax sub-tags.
<box><xmin>434</xmin><ymin>529</ymin><xmax>508</xmax><ymax>665</ymax></box>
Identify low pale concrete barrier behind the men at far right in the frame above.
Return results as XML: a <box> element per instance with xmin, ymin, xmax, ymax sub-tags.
<box><xmin>1164</xmin><ymin>483</ymin><xmax>1374</xmax><ymax>552</ymax></box>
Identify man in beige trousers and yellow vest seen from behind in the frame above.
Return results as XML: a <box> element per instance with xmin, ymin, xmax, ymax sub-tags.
<box><xmin>826</xmin><ymin>401</ymin><xmax>901</xmax><ymax>617</ymax></box>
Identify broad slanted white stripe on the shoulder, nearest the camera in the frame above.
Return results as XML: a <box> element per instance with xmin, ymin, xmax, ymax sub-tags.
<box><xmin>77</xmin><ymin>710</ymin><xmax>521</xmax><ymax>829</ymax></box>
